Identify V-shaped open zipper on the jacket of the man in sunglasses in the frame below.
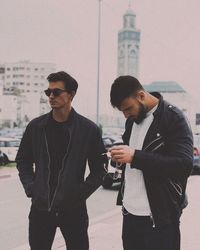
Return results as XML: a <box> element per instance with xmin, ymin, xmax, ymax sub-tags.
<box><xmin>45</xmin><ymin>130</ymin><xmax>71</xmax><ymax>212</ymax></box>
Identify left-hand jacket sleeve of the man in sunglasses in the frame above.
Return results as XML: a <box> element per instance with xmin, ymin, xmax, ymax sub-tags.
<box><xmin>15</xmin><ymin>124</ymin><xmax>34</xmax><ymax>197</ymax></box>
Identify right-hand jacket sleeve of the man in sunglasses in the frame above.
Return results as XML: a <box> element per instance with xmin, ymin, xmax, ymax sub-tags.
<box><xmin>81</xmin><ymin>128</ymin><xmax>106</xmax><ymax>199</ymax></box>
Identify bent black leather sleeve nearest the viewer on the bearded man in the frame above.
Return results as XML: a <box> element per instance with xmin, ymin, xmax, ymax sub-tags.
<box><xmin>131</xmin><ymin>117</ymin><xmax>193</xmax><ymax>178</ymax></box>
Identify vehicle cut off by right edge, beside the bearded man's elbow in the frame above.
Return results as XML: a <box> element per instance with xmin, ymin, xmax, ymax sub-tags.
<box><xmin>192</xmin><ymin>134</ymin><xmax>200</xmax><ymax>174</ymax></box>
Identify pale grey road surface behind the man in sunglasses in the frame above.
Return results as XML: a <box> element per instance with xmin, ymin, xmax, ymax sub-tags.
<box><xmin>0</xmin><ymin>169</ymin><xmax>117</xmax><ymax>250</ymax></box>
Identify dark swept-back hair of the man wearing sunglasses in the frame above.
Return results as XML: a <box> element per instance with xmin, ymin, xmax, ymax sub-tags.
<box><xmin>47</xmin><ymin>71</ymin><xmax>78</xmax><ymax>93</ymax></box>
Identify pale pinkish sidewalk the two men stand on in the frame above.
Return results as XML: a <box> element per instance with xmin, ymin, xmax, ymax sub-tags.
<box><xmin>6</xmin><ymin>172</ymin><xmax>200</xmax><ymax>250</ymax></box>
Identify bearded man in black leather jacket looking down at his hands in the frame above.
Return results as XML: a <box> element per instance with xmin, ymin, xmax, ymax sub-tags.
<box><xmin>110</xmin><ymin>76</ymin><xmax>193</xmax><ymax>250</ymax></box>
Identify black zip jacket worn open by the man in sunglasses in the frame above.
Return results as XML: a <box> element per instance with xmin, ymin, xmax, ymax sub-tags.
<box><xmin>16</xmin><ymin>109</ymin><xmax>105</xmax><ymax>211</ymax></box>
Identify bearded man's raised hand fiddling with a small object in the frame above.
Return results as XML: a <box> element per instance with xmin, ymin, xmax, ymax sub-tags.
<box><xmin>109</xmin><ymin>145</ymin><xmax>135</xmax><ymax>163</ymax></box>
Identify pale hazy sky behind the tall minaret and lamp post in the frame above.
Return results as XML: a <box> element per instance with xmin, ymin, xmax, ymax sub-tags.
<box><xmin>0</xmin><ymin>0</ymin><xmax>200</xmax><ymax>116</ymax></box>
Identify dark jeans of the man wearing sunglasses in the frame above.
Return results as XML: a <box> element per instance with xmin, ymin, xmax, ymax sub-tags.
<box><xmin>29</xmin><ymin>206</ymin><xmax>89</xmax><ymax>250</ymax></box>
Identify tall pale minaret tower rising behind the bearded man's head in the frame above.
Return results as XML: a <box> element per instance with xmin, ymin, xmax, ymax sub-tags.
<box><xmin>118</xmin><ymin>1</ymin><xmax>140</xmax><ymax>78</ymax></box>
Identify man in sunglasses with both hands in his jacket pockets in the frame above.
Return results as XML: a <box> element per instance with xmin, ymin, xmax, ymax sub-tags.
<box><xmin>16</xmin><ymin>72</ymin><xmax>105</xmax><ymax>250</ymax></box>
